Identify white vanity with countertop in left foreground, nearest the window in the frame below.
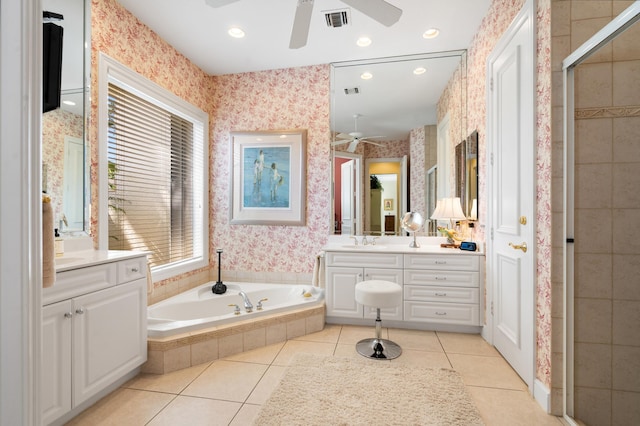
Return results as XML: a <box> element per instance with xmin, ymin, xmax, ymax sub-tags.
<box><xmin>40</xmin><ymin>250</ymin><xmax>147</xmax><ymax>424</ymax></box>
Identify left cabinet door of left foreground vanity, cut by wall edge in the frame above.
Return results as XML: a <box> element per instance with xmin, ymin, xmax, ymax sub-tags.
<box><xmin>40</xmin><ymin>300</ymin><xmax>73</xmax><ymax>424</ymax></box>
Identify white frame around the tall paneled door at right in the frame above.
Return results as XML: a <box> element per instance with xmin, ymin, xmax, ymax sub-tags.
<box><xmin>481</xmin><ymin>0</ymin><xmax>536</xmax><ymax>392</ymax></box>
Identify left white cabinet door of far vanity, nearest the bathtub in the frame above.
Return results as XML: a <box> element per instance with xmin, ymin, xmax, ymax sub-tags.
<box><xmin>326</xmin><ymin>267</ymin><xmax>363</xmax><ymax>318</ymax></box>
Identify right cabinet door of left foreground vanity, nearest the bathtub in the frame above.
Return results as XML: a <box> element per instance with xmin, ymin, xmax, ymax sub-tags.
<box><xmin>73</xmin><ymin>279</ymin><xmax>147</xmax><ymax>405</ymax></box>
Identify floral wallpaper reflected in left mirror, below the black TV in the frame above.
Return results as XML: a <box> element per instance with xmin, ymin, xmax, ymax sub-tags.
<box><xmin>42</xmin><ymin>108</ymin><xmax>83</xmax><ymax>223</ymax></box>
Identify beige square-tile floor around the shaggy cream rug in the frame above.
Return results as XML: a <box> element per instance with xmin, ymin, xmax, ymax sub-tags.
<box><xmin>68</xmin><ymin>325</ymin><xmax>563</xmax><ymax>426</ymax></box>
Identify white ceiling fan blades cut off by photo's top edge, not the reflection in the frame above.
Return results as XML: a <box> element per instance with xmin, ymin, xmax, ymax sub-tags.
<box><xmin>205</xmin><ymin>0</ymin><xmax>402</xmax><ymax>49</ymax></box>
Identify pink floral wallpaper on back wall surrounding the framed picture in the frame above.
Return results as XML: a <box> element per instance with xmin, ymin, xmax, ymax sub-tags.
<box><xmin>210</xmin><ymin>65</ymin><xmax>331</xmax><ymax>273</ymax></box>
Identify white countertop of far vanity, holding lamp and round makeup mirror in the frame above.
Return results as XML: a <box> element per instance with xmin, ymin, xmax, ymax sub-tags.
<box><xmin>322</xmin><ymin>236</ymin><xmax>484</xmax><ymax>256</ymax></box>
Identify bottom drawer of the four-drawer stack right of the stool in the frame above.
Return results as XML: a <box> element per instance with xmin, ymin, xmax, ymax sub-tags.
<box><xmin>404</xmin><ymin>301</ymin><xmax>480</xmax><ymax>325</ymax></box>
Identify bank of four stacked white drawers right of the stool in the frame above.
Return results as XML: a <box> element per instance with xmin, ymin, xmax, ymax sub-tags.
<box><xmin>404</xmin><ymin>254</ymin><xmax>481</xmax><ymax>326</ymax></box>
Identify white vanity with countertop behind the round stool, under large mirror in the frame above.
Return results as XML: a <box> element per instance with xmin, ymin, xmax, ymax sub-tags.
<box><xmin>323</xmin><ymin>237</ymin><xmax>484</xmax><ymax>333</ymax></box>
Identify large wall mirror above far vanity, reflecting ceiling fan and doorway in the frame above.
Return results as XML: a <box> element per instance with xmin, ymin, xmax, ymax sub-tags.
<box><xmin>331</xmin><ymin>51</ymin><xmax>466</xmax><ymax>235</ymax></box>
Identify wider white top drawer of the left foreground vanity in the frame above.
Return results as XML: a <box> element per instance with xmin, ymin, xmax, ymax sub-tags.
<box><xmin>42</xmin><ymin>263</ymin><xmax>117</xmax><ymax>305</ymax></box>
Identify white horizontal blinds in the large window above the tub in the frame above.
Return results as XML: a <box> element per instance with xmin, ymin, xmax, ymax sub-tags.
<box><xmin>107</xmin><ymin>83</ymin><xmax>204</xmax><ymax>267</ymax></box>
